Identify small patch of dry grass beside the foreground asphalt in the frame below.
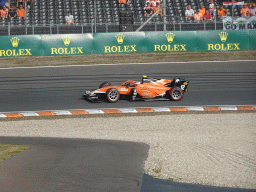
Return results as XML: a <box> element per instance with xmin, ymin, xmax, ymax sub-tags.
<box><xmin>0</xmin><ymin>143</ymin><xmax>29</xmax><ymax>162</ymax></box>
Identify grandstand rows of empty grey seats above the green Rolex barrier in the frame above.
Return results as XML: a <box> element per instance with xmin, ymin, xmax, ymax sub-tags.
<box><xmin>0</xmin><ymin>0</ymin><xmax>255</xmax><ymax>35</ymax></box>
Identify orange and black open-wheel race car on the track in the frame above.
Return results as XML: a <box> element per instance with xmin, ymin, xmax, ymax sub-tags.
<box><xmin>83</xmin><ymin>75</ymin><xmax>189</xmax><ymax>103</ymax></box>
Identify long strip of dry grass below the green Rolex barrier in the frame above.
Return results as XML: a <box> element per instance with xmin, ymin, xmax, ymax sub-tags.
<box><xmin>0</xmin><ymin>51</ymin><xmax>256</xmax><ymax>68</ymax></box>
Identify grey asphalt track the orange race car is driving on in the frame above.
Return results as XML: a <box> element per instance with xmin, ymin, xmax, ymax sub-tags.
<box><xmin>0</xmin><ymin>61</ymin><xmax>256</xmax><ymax>112</ymax></box>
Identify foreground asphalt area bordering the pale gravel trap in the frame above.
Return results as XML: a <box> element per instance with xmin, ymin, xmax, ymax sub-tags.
<box><xmin>0</xmin><ymin>137</ymin><xmax>255</xmax><ymax>192</ymax></box>
